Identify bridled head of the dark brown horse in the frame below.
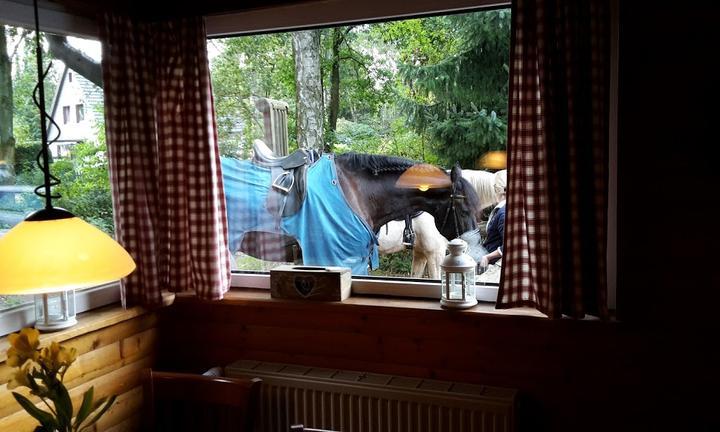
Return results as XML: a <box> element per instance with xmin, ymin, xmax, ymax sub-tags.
<box><xmin>433</xmin><ymin>165</ymin><xmax>480</xmax><ymax>247</ymax></box>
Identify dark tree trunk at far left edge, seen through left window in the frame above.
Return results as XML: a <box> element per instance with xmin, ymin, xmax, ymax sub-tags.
<box><xmin>0</xmin><ymin>26</ymin><xmax>15</xmax><ymax>184</ymax></box>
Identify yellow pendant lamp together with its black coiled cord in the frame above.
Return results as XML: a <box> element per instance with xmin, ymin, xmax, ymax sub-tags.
<box><xmin>0</xmin><ymin>0</ymin><xmax>135</xmax><ymax>329</ymax></box>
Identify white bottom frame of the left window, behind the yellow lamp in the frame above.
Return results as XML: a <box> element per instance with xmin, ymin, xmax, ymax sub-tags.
<box><xmin>0</xmin><ymin>282</ymin><xmax>120</xmax><ymax>336</ymax></box>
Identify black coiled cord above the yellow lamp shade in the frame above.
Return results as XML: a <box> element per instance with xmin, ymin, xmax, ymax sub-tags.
<box><xmin>33</xmin><ymin>0</ymin><xmax>60</xmax><ymax>209</ymax></box>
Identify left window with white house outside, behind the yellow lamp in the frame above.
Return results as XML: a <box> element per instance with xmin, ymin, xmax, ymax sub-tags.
<box><xmin>0</xmin><ymin>26</ymin><xmax>119</xmax><ymax>335</ymax></box>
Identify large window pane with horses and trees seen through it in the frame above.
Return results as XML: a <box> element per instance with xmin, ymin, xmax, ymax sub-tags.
<box><xmin>208</xmin><ymin>9</ymin><xmax>510</xmax><ymax>283</ymax></box>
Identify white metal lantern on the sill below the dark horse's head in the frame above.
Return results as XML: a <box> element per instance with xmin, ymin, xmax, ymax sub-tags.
<box><xmin>440</xmin><ymin>238</ymin><xmax>477</xmax><ymax>309</ymax></box>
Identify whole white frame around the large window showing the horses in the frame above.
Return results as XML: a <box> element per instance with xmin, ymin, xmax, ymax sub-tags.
<box><xmin>219</xmin><ymin>0</ymin><xmax>619</xmax><ymax>310</ymax></box>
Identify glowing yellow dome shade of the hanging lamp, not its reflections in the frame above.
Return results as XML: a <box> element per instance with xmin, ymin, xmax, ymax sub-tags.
<box><xmin>0</xmin><ymin>209</ymin><xmax>135</xmax><ymax>294</ymax></box>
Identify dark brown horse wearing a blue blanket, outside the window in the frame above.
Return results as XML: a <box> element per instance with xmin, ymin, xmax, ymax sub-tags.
<box><xmin>223</xmin><ymin>153</ymin><xmax>479</xmax><ymax>274</ymax></box>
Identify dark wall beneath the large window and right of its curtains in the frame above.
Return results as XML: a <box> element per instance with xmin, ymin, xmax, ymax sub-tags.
<box><xmin>153</xmin><ymin>1</ymin><xmax>720</xmax><ymax>431</ymax></box>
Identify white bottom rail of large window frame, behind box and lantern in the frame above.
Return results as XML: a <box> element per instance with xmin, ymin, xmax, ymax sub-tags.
<box><xmin>230</xmin><ymin>272</ymin><xmax>498</xmax><ymax>303</ymax></box>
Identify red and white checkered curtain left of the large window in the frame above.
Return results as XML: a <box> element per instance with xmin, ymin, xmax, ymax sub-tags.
<box><xmin>101</xmin><ymin>15</ymin><xmax>230</xmax><ymax>307</ymax></box>
